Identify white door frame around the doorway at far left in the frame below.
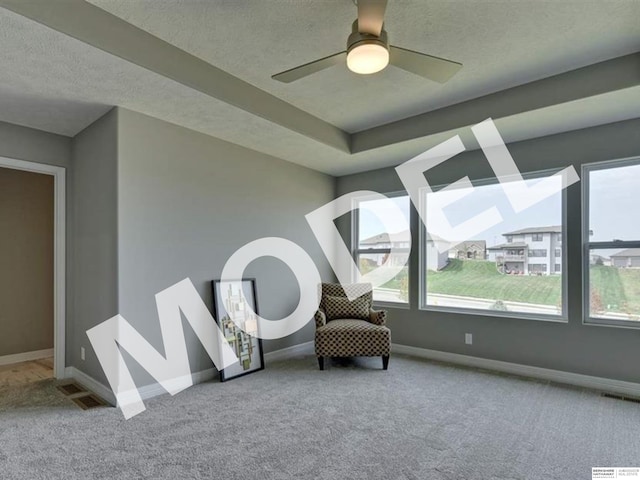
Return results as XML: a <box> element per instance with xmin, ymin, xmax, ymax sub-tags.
<box><xmin>0</xmin><ymin>156</ymin><xmax>67</xmax><ymax>378</ymax></box>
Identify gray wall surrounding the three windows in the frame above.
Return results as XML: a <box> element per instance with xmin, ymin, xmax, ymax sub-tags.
<box><xmin>337</xmin><ymin>120</ymin><xmax>640</xmax><ymax>382</ymax></box>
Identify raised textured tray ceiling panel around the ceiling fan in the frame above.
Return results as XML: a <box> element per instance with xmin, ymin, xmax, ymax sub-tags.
<box><xmin>86</xmin><ymin>0</ymin><xmax>640</xmax><ymax>132</ymax></box>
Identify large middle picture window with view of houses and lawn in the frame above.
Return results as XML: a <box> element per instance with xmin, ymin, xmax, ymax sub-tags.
<box><xmin>420</xmin><ymin>172</ymin><xmax>566</xmax><ymax>320</ymax></box>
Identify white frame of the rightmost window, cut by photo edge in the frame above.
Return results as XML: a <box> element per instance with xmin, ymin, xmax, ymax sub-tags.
<box><xmin>581</xmin><ymin>156</ymin><xmax>640</xmax><ymax>329</ymax></box>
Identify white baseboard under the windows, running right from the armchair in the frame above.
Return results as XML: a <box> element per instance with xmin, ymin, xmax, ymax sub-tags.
<box><xmin>391</xmin><ymin>344</ymin><xmax>640</xmax><ymax>397</ymax></box>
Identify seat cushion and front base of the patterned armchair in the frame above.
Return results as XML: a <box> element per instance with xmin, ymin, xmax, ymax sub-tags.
<box><xmin>315</xmin><ymin>318</ymin><xmax>391</xmax><ymax>357</ymax></box>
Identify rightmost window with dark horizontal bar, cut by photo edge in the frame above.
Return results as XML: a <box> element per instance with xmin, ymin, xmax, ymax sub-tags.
<box><xmin>582</xmin><ymin>158</ymin><xmax>640</xmax><ymax>327</ymax></box>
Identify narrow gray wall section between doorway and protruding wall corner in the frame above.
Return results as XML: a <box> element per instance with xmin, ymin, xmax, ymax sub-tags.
<box><xmin>67</xmin><ymin>109</ymin><xmax>118</xmax><ymax>384</ymax></box>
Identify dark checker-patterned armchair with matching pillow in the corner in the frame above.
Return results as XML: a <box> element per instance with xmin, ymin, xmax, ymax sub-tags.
<box><xmin>315</xmin><ymin>283</ymin><xmax>391</xmax><ymax>370</ymax></box>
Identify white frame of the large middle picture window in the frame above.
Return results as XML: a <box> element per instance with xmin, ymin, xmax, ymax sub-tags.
<box><xmin>418</xmin><ymin>168</ymin><xmax>569</xmax><ymax>323</ymax></box>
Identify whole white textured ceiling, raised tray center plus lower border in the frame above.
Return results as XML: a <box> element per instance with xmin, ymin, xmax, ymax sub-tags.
<box><xmin>0</xmin><ymin>0</ymin><xmax>640</xmax><ymax>175</ymax></box>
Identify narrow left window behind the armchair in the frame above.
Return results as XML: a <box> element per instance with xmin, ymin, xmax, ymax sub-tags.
<box><xmin>353</xmin><ymin>195</ymin><xmax>411</xmax><ymax>303</ymax></box>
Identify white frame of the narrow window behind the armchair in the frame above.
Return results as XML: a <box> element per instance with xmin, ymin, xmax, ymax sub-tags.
<box><xmin>351</xmin><ymin>190</ymin><xmax>413</xmax><ymax>309</ymax></box>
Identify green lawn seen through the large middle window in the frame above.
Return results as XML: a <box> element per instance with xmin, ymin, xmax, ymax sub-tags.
<box><xmin>427</xmin><ymin>259</ymin><xmax>562</xmax><ymax>306</ymax></box>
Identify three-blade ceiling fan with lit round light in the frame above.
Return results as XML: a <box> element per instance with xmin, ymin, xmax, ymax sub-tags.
<box><xmin>271</xmin><ymin>0</ymin><xmax>462</xmax><ymax>83</ymax></box>
